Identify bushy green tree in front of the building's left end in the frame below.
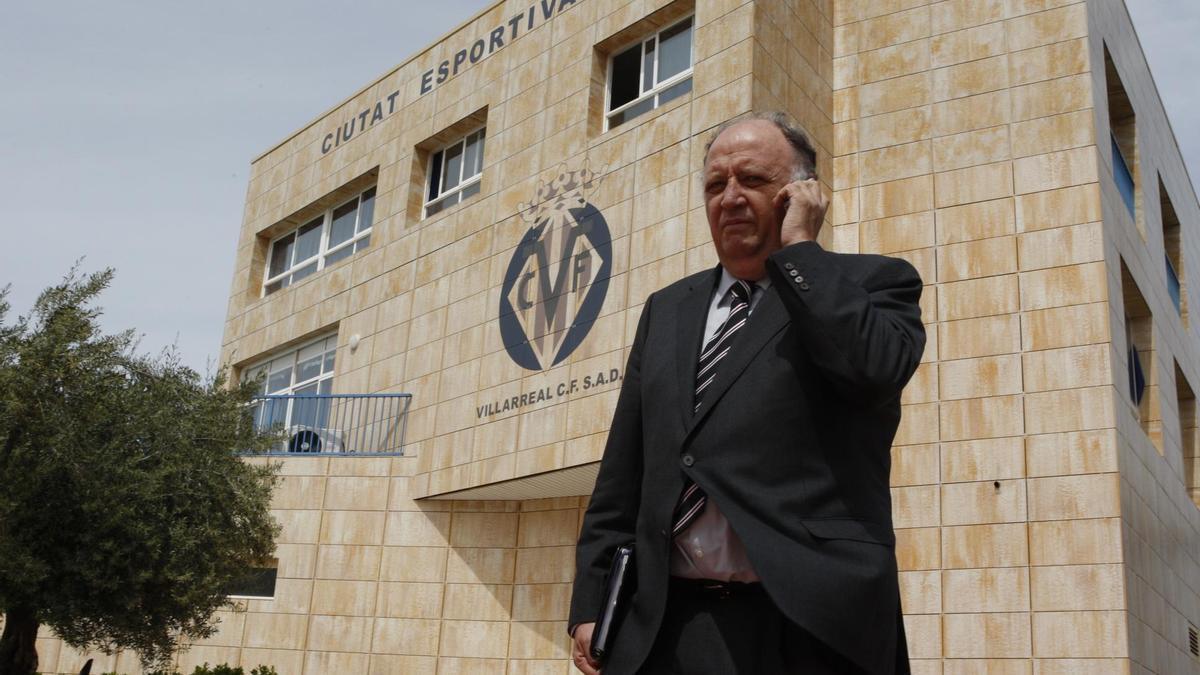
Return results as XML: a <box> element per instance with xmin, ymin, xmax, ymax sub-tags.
<box><xmin>0</xmin><ymin>270</ymin><xmax>277</xmax><ymax>675</ymax></box>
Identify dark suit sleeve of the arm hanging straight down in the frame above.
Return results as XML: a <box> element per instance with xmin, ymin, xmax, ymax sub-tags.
<box><xmin>568</xmin><ymin>295</ymin><xmax>654</xmax><ymax>632</ymax></box>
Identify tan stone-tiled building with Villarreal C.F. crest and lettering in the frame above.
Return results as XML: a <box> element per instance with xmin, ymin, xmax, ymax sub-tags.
<box><xmin>38</xmin><ymin>0</ymin><xmax>1200</xmax><ymax>675</ymax></box>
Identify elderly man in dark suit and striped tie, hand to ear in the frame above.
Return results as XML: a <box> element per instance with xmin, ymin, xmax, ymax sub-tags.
<box><xmin>570</xmin><ymin>113</ymin><xmax>925</xmax><ymax>675</ymax></box>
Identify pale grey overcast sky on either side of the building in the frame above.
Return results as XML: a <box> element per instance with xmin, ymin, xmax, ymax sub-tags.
<box><xmin>0</xmin><ymin>0</ymin><xmax>1200</xmax><ymax>372</ymax></box>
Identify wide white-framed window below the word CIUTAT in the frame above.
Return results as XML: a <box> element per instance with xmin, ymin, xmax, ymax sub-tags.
<box><xmin>263</xmin><ymin>187</ymin><xmax>376</xmax><ymax>295</ymax></box>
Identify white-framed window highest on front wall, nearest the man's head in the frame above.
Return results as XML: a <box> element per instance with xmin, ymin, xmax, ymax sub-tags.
<box><xmin>605</xmin><ymin>17</ymin><xmax>692</xmax><ymax>129</ymax></box>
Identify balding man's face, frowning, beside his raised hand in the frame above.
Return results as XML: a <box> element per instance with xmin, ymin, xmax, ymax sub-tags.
<box><xmin>704</xmin><ymin>120</ymin><xmax>796</xmax><ymax>280</ymax></box>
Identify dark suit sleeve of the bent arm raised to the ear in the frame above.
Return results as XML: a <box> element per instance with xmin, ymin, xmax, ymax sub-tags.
<box><xmin>767</xmin><ymin>241</ymin><xmax>925</xmax><ymax>406</ymax></box>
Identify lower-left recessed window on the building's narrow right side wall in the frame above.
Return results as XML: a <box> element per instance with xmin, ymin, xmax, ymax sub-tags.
<box><xmin>1121</xmin><ymin>261</ymin><xmax>1163</xmax><ymax>454</ymax></box>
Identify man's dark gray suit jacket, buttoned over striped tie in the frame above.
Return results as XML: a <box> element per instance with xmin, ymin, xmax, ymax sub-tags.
<box><xmin>570</xmin><ymin>243</ymin><xmax>925</xmax><ymax>675</ymax></box>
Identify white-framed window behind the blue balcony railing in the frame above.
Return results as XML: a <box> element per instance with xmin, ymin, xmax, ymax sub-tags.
<box><xmin>244</xmin><ymin>334</ymin><xmax>337</xmax><ymax>437</ymax></box>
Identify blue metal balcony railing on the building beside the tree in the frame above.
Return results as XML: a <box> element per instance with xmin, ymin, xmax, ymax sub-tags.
<box><xmin>243</xmin><ymin>394</ymin><xmax>413</xmax><ymax>455</ymax></box>
